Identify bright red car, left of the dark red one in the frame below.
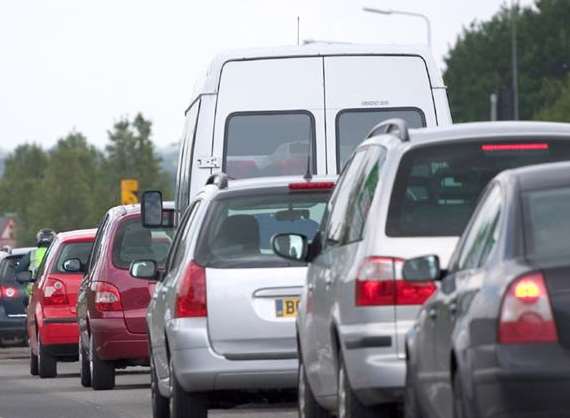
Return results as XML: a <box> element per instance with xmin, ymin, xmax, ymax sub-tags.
<box><xmin>27</xmin><ymin>229</ymin><xmax>97</xmax><ymax>377</ymax></box>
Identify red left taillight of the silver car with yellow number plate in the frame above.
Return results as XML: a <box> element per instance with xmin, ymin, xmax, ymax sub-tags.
<box><xmin>175</xmin><ymin>261</ymin><xmax>208</xmax><ymax>318</ymax></box>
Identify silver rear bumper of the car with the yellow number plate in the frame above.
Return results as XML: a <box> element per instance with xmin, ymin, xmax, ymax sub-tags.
<box><xmin>167</xmin><ymin>319</ymin><xmax>299</xmax><ymax>392</ymax></box>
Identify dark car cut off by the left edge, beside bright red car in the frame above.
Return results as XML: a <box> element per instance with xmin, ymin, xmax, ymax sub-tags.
<box><xmin>0</xmin><ymin>248</ymin><xmax>32</xmax><ymax>346</ymax></box>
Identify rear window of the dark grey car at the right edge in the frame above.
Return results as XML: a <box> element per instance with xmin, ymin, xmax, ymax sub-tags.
<box><xmin>523</xmin><ymin>187</ymin><xmax>570</xmax><ymax>259</ymax></box>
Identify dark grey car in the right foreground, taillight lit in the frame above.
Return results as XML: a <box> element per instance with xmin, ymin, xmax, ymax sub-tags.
<box><xmin>403</xmin><ymin>163</ymin><xmax>570</xmax><ymax>418</ymax></box>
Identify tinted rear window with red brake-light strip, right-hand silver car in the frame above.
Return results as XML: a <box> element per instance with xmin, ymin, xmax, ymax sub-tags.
<box><xmin>386</xmin><ymin>140</ymin><xmax>570</xmax><ymax>237</ymax></box>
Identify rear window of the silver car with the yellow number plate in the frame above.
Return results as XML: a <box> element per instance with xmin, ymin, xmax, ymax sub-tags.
<box><xmin>197</xmin><ymin>191</ymin><xmax>329</xmax><ymax>268</ymax></box>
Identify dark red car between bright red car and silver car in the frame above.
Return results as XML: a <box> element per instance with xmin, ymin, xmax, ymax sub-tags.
<box><xmin>77</xmin><ymin>205</ymin><xmax>173</xmax><ymax>390</ymax></box>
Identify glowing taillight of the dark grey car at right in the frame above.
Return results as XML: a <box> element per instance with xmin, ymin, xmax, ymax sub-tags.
<box><xmin>499</xmin><ymin>273</ymin><xmax>558</xmax><ymax>344</ymax></box>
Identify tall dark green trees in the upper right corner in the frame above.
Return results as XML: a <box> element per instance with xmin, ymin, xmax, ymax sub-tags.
<box><xmin>444</xmin><ymin>0</ymin><xmax>570</xmax><ymax>122</ymax></box>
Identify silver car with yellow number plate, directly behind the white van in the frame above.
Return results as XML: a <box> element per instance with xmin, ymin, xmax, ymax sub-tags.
<box><xmin>131</xmin><ymin>175</ymin><xmax>334</xmax><ymax>418</ymax></box>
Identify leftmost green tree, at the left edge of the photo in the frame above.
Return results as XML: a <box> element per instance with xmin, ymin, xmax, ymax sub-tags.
<box><xmin>0</xmin><ymin>144</ymin><xmax>48</xmax><ymax>245</ymax></box>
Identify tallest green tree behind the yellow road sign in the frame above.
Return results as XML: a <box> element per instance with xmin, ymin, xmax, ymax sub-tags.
<box><xmin>105</xmin><ymin>113</ymin><xmax>170</xmax><ymax>205</ymax></box>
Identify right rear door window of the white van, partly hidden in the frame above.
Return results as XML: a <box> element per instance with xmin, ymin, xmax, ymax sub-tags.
<box><xmin>336</xmin><ymin>108</ymin><xmax>426</xmax><ymax>171</ymax></box>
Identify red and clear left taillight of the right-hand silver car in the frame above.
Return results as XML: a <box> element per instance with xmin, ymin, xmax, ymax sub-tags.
<box><xmin>355</xmin><ymin>257</ymin><xmax>436</xmax><ymax>306</ymax></box>
